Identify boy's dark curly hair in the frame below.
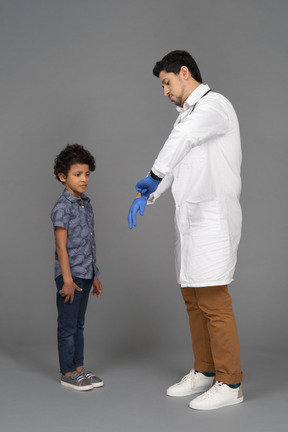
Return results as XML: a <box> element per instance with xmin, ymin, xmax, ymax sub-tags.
<box><xmin>54</xmin><ymin>144</ymin><xmax>96</xmax><ymax>181</ymax></box>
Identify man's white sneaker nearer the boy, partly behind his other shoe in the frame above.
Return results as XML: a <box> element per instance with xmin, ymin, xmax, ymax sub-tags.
<box><xmin>166</xmin><ymin>369</ymin><xmax>214</xmax><ymax>397</ymax></box>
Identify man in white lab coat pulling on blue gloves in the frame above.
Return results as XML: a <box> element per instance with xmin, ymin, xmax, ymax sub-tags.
<box><xmin>128</xmin><ymin>51</ymin><xmax>243</xmax><ymax>410</ymax></box>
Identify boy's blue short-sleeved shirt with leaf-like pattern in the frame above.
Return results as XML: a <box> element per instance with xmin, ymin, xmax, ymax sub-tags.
<box><xmin>51</xmin><ymin>189</ymin><xmax>99</xmax><ymax>279</ymax></box>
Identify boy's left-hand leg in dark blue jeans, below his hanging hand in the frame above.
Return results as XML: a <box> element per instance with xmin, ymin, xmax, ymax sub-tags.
<box><xmin>55</xmin><ymin>276</ymin><xmax>82</xmax><ymax>374</ymax></box>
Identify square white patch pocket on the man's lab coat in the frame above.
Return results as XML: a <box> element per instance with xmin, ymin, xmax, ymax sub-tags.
<box><xmin>186</xmin><ymin>200</ymin><xmax>220</xmax><ymax>236</ymax></box>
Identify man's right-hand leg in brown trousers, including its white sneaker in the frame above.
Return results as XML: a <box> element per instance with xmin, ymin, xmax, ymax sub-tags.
<box><xmin>189</xmin><ymin>285</ymin><xmax>244</xmax><ymax>410</ymax></box>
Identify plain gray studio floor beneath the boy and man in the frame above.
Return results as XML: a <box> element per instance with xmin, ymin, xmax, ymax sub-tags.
<box><xmin>0</xmin><ymin>346</ymin><xmax>288</xmax><ymax>432</ymax></box>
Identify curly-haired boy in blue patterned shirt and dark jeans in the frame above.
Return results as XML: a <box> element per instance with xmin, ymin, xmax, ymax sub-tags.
<box><xmin>51</xmin><ymin>144</ymin><xmax>104</xmax><ymax>391</ymax></box>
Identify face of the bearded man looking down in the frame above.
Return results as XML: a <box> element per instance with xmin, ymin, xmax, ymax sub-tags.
<box><xmin>159</xmin><ymin>70</ymin><xmax>187</xmax><ymax>107</ymax></box>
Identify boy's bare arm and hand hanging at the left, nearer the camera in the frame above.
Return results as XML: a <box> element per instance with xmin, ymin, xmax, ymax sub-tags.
<box><xmin>55</xmin><ymin>226</ymin><xmax>82</xmax><ymax>303</ymax></box>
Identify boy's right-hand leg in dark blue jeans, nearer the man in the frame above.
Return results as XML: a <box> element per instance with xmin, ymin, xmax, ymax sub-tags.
<box><xmin>74</xmin><ymin>278</ymin><xmax>93</xmax><ymax>371</ymax></box>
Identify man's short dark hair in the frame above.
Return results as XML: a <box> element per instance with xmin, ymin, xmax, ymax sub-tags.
<box><xmin>153</xmin><ymin>51</ymin><xmax>203</xmax><ymax>83</ymax></box>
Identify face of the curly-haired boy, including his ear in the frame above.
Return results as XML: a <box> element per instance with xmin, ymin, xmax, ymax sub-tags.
<box><xmin>59</xmin><ymin>163</ymin><xmax>90</xmax><ymax>198</ymax></box>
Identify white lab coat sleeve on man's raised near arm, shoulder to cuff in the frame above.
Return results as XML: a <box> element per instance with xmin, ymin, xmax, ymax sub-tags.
<box><xmin>152</xmin><ymin>98</ymin><xmax>229</xmax><ymax>177</ymax></box>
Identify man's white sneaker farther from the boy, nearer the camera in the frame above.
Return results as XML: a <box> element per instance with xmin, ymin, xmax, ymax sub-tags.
<box><xmin>189</xmin><ymin>381</ymin><xmax>244</xmax><ymax>410</ymax></box>
